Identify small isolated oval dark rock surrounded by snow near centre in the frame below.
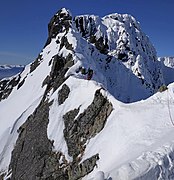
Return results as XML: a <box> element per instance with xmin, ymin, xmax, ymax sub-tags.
<box><xmin>58</xmin><ymin>84</ymin><xmax>70</xmax><ymax>105</ymax></box>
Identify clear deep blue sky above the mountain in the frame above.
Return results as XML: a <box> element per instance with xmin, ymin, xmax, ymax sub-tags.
<box><xmin>0</xmin><ymin>0</ymin><xmax>174</xmax><ymax>64</ymax></box>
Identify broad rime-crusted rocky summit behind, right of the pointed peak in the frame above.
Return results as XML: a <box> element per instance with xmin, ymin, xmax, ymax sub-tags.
<box><xmin>71</xmin><ymin>13</ymin><xmax>164</xmax><ymax>100</ymax></box>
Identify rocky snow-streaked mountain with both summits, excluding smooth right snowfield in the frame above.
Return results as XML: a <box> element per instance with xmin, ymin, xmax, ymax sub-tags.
<box><xmin>0</xmin><ymin>8</ymin><xmax>170</xmax><ymax>180</ymax></box>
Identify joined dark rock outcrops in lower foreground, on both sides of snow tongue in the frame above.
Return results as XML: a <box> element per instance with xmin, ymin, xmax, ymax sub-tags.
<box><xmin>9</xmin><ymin>90</ymin><xmax>112</xmax><ymax>180</ymax></box>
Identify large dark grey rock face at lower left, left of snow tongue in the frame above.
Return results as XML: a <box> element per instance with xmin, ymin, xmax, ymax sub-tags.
<box><xmin>10</xmin><ymin>97</ymin><xmax>69</xmax><ymax>180</ymax></box>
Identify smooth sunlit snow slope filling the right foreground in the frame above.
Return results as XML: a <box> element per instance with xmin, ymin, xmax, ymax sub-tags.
<box><xmin>84</xmin><ymin>84</ymin><xmax>174</xmax><ymax>180</ymax></box>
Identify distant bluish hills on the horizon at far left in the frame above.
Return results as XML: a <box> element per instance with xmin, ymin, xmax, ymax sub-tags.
<box><xmin>0</xmin><ymin>65</ymin><xmax>24</xmax><ymax>79</ymax></box>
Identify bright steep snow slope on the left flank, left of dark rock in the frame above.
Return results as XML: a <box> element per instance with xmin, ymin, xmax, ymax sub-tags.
<box><xmin>0</xmin><ymin>40</ymin><xmax>55</xmax><ymax>172</ymax></box>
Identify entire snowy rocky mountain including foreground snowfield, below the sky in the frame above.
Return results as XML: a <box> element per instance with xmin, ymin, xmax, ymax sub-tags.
<box><xmin>0</xmin><ymin>8</ymin><xmax>174</xmax><ymax>180</ymax></box>
